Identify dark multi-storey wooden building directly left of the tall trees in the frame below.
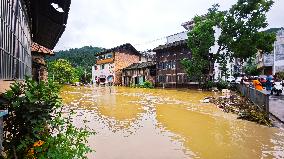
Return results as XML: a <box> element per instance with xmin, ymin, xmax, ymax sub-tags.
<box><xmin>153</xmin><ymin>40</ymin><xmax>191</xmax><ymax>87</ymax></box>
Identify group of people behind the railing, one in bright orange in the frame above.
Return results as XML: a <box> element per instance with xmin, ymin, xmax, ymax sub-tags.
<box><xmin>241</xmin><ymin>75</ymin><xmax>281</xmax><ymax>93</ymax></box>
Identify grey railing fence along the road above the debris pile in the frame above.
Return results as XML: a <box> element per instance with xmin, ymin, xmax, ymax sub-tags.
<box><xmin>237</xmin><ymin>84</ymin><xmax>269</xmax><ymax>113</ymax></box>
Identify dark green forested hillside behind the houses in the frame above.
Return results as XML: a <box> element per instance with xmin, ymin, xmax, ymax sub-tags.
<box><xmin>46</xmin><ymin>46</ymin><xmax>103</xmax><ymax>70</ymax></box>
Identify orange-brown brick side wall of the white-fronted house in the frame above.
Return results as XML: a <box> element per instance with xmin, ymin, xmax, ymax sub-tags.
<box><xmin>114</xmin><ymin>52</ymin><xmax>139</xmax><ymax>85</ymax></box>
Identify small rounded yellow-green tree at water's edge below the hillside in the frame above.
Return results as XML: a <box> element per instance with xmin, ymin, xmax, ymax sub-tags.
<box><xmin>48</xmin><ymin>59</ymin><xmax>77</xmax><ymax>84</ymax></box>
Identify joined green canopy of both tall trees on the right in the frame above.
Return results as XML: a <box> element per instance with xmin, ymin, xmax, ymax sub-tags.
<box><xmin>181</xmin><ymin>0</ymin><xmax>276</xmax><ymax>82</ymax></box>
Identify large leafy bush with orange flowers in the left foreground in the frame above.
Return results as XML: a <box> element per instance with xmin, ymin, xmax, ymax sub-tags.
<box><xmin>0</xmin><ymin>78</ymin><xmax>93</xmax><ymax>158</ymax></box>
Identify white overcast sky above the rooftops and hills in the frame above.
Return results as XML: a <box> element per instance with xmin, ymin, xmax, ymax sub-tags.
<box><xmin>55</xmin><ymin>0</ymin><xmax>284</xmax><ymax>51</ymax></box>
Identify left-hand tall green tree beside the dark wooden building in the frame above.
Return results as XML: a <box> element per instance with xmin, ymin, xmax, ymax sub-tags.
<box><xmin>181</xmin><ymin>4</ymin><xmax>224</xmax><ymax>82</ymax></box>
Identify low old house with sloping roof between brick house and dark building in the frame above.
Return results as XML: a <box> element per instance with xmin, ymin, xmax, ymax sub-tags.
<box><xmin>122</xmin><ymin>62</ymin><xmax>156</xmax><ymax>86</ymax></box>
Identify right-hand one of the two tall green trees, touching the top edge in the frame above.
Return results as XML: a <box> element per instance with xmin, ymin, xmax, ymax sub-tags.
<box><xmin>218</xmin><ymin>0</ymin><xmax>275</xmax><ymax>61</ymax></box>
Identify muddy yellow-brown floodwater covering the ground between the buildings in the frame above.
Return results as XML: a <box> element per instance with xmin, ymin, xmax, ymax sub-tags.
<box><xmin>61</xmin><ymin>86</ymin><xmax>284</xmax><ymax>159</ymax></box>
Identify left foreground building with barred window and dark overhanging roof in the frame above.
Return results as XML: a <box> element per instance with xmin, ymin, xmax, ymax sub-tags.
<box><xmin>0</xmin><ymin>0</ymin><xmax>71</xmax><ymax>94</ymax></box>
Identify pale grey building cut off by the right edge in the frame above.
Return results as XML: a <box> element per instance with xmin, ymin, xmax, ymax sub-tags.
<box><xmin>273</xmin><ymin>28</ymin><xmax>284</xmax><ymax>74</ymax></box>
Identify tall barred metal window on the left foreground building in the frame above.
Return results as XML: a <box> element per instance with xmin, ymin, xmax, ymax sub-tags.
<box><xmin>0</xmin><ymin>0</ymin><xmax>32</xmax><ymax>80</ymax></box>
